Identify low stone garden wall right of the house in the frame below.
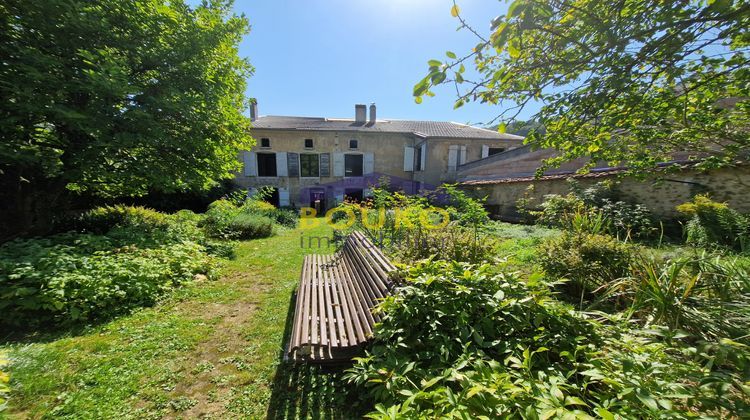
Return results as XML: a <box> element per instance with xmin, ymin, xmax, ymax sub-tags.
<box><xmin>464</xmin><ymin>165</ymin><xmax>750</xmax><ymax>220</ymax></box>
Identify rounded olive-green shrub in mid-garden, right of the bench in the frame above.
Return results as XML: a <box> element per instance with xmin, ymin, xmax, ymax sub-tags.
<box><xmin>539</xmin><ymin>232</ymin><xmax>635</xmax><ymax>299</ymax></box>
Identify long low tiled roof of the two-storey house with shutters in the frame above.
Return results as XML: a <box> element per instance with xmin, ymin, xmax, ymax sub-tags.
<box><xmin>253</xmin><ymin>115</ymin><xmax>523</xmax><ymax>140</ymax></box>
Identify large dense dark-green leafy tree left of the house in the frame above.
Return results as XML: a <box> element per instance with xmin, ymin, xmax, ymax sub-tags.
<box><xmin>0</xmin><ymin>0</ymin><xmax>252</xmax><ymax>236</ymax></box>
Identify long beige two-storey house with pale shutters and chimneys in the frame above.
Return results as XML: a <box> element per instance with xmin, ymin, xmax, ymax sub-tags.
<box><xmin>235</xmin><ymin>104</ymin><xmax>523</xmax><ymax>211</ymax></box>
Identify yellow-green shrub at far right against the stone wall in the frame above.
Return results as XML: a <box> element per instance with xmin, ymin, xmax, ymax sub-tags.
<box><xmin>677</xmin><ymin>195</ymin><xmax>750</xmax><ymax>251</ymax></box>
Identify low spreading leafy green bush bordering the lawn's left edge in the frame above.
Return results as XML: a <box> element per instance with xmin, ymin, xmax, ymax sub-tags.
<box><xmin>0</xmin><ymin>233</ymin><xmax>215</xmax><ymax>327</ymax></box>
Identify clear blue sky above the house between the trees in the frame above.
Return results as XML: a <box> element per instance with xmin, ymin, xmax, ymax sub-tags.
<box><xmin>226</xmin><ymin>0</ymin><xmax>528</xmax><ymax>124</ymax></box>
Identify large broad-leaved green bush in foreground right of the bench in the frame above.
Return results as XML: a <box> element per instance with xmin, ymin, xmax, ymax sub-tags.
<box><xmin>347</xmin><ymin>262</ymin><xmax>747</xmax><ymax>419</ymax></box>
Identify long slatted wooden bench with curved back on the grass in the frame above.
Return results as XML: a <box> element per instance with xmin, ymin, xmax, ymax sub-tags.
<box><xmin>286</xmin><ymin>232</ymin><xmax>395</xmax><ymax>363</ymax></box>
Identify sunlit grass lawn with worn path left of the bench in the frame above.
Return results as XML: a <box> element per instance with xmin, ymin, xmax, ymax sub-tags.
<box><xmin>0</xmin><ymin>227</ymin><xmax>362</xmax><ymax>418</ymax></box>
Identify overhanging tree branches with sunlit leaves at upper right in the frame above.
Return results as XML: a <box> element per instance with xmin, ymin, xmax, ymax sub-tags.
<box><xmin>414</xmin><ymin>0</ymin><xmax>750</xmax><ymax>174</ymax></box>
